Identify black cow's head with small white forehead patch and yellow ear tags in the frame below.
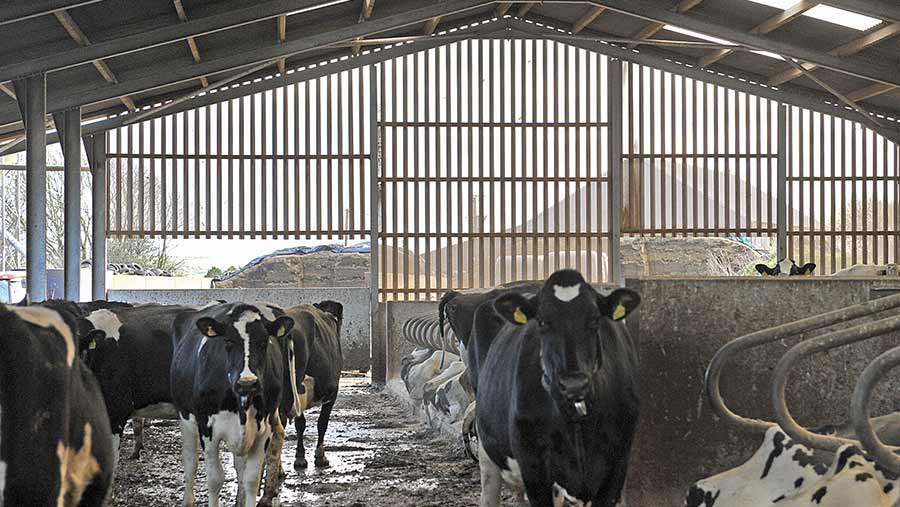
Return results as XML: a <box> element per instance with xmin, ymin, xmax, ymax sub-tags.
<box><xmin>494</xmin><ymin>270</ymin><xmax>640</xmax><ymax>417</ymax></box>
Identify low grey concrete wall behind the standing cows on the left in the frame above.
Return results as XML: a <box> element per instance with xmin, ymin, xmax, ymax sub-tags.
<box><xmin>109</xmin><ymin>287</ymin><xmax>371</xmax><ymax>371</ymax></box>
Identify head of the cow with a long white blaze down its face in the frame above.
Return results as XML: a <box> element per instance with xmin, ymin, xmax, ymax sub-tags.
<box><xmin>197</xmin><ymin>305</ymin><xmax>294</xmax><ymax>410</ymax></box>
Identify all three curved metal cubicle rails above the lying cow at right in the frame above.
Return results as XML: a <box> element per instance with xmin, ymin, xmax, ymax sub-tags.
<box><xmin>705</xmin><ymin>294</ymin><xmax>900</xmax><ymax>471</ymax></box>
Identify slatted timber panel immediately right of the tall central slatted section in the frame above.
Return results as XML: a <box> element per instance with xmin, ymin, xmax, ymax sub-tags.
<box><xmin>622</xmin><ymin>64</ymin><xmax>778</xmax><ymax>237</ymax></box>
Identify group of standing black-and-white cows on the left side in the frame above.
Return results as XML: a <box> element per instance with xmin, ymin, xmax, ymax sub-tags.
<box><xmin>0</xmin><ymin>300</ymin><xmax>343</xmax><ymax>507</ymax></box>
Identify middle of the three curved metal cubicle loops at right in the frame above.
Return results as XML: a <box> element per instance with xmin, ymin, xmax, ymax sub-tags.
<box><xmin>772</xmin><ymin>316</ymin><xmax>900</xmax><ymax>452</ymax></box>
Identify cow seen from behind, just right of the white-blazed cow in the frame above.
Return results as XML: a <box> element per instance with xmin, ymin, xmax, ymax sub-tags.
<box><xmin>260</xmin><ymin>300</ymin><xmax>344</xmax><ymax>505</ymax></box>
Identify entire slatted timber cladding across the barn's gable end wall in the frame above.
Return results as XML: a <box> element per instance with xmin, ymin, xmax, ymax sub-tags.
<box><xmin>102</xmin><ymin>37</ymin><xmax>900</xmax><ymax>301</ymax></box>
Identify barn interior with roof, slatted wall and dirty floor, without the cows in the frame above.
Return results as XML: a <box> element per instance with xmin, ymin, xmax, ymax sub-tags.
<box><xmin>0</xmin><ymin>0</ymin><xmax>900</xmax><ymax>507</ymax></box>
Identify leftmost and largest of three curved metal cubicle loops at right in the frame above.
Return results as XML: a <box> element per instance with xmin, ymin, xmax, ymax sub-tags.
<box><xmin>705</xmin><ymin>294</ymin><xmax>900</xmax><ymax>431</ymax></box>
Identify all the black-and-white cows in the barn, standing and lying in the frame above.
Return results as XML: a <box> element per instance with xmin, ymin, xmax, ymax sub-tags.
<box><xmin>0</xmin><ymin>261</ymin><xmax>900</xmax><ymax>507</ymax></box>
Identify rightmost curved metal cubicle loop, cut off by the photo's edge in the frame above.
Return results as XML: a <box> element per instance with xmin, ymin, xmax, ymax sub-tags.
<box><xmin>850</xmin><ymin>347</ymin><xmax>900</xmax><ymax>473</ymax></box>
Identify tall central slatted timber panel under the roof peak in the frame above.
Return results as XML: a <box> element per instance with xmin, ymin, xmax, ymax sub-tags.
<box><xmin>380</xmin><ymin>39</ymin><xmax>609</xmax><ymax>299</ymax></box>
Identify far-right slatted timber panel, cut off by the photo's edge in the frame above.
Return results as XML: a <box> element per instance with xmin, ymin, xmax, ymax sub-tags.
<box><xmin>787</xmin><ymin>107</ymin><xmax>900</xmax><ymax>273</ymax></box>
